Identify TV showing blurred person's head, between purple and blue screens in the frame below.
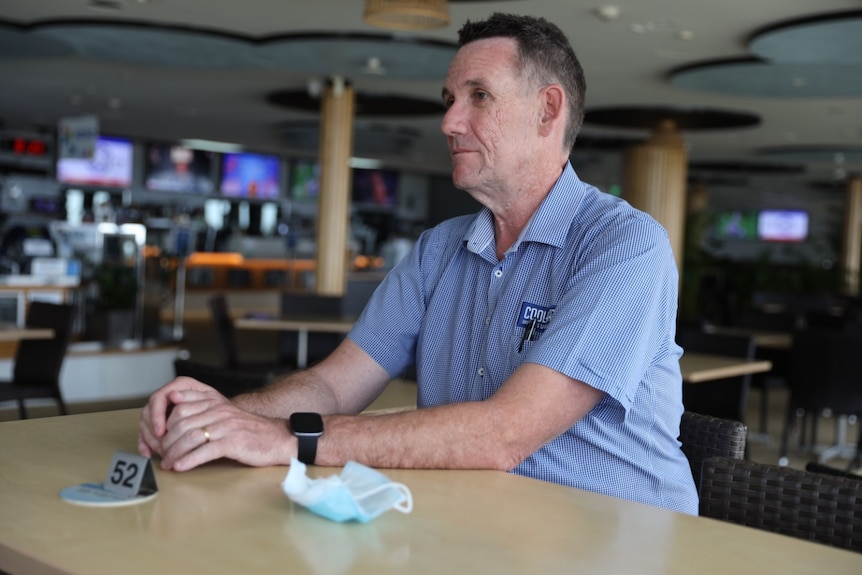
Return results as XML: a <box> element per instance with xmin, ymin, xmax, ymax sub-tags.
<box><xmin>144</xmin><ymin>144</ymin><xmax>215</xmax><ymax>194</ymax></box>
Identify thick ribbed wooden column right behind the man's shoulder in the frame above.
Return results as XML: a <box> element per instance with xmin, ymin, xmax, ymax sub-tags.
<box><xmin>623</xmin><ymin>120</ymin><xmax>688</xmax><ymax>272</ymax></box>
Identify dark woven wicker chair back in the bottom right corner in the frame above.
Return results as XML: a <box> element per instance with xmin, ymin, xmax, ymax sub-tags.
<box><xmin>700</xmin><ymin>457</ymin><xmax>862</xmax><ymax>552</ymax></box>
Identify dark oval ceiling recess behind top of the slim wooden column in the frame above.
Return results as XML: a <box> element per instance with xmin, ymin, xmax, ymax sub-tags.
<box><xmin>266</xmin><ymin>90</ymin><xmax>446</xmax><ymax>117</ymax></box>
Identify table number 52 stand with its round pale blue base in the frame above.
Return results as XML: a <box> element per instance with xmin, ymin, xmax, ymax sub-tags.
<box><xmin>60</xmin><ymin>451</ymin><xmax>159</xmax><ymax>507</ymax></box>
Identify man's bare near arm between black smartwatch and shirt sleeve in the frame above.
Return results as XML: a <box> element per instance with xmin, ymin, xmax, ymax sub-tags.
<box><xmin>316</xmin><ymin>363</ymin><xmax>604</xmax><ymax>471</ymax></box>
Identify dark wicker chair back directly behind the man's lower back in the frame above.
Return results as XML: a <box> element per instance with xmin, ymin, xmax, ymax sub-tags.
<box><xmin>679</xmin><ymin>411</ymin><xmax>748</xmax><ymax>491</ymax></box>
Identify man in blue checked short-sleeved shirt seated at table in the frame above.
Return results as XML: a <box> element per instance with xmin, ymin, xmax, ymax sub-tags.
<box><xmin>139</xmin><ymin>14</ymin><xmax>697</xmax><ymax>513</ymax></box>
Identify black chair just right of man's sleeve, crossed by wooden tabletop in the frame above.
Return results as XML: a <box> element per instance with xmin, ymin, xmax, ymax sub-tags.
<box><xmin>677</xmin><ymin>329</ymin><xmax>755</xmax><ymax>422</ymax></box>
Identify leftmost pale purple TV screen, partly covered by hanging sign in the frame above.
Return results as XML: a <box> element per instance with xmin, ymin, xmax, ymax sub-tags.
<box><xmin>57</xmin><ymin>136</ymin><xmax>134</xmax><ymax>188</ymax></box>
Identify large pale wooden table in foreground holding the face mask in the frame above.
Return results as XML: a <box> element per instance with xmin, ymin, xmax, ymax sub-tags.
<box><xmin>0</xmin><ymin>410</ymin><xmax>862</xmax><ymax>575</ymax></box>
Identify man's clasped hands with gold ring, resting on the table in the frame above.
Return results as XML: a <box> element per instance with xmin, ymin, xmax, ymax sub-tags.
<box><xmin>138</xmin><ymin>377</ymin><xmax>297</xmax><ymax>471</ymax></box>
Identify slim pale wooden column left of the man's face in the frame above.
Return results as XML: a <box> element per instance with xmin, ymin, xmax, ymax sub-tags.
<box><xmin>315</xmin><ymin>78</ymin><xmax>356</xmax><ymax>296</ymax></box>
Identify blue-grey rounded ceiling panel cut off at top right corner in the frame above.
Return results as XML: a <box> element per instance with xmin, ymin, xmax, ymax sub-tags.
<box><xmin>749</xmin><ymin>12</ymin><xmax>862</xmax><ymax>66</ymax></box>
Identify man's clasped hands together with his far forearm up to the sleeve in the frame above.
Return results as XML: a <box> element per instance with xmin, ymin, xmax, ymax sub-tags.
<box><xmin>138</xmin><ymin>340</ymin><xmax>389</xmax><ymax>471</ymax></box>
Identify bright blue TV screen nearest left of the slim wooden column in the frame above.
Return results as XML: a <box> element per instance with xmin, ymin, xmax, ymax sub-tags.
<box><xmin>221</xmin><ymin>152</ymin><xmax>281</xmax><ymax>200</ymax></box>
